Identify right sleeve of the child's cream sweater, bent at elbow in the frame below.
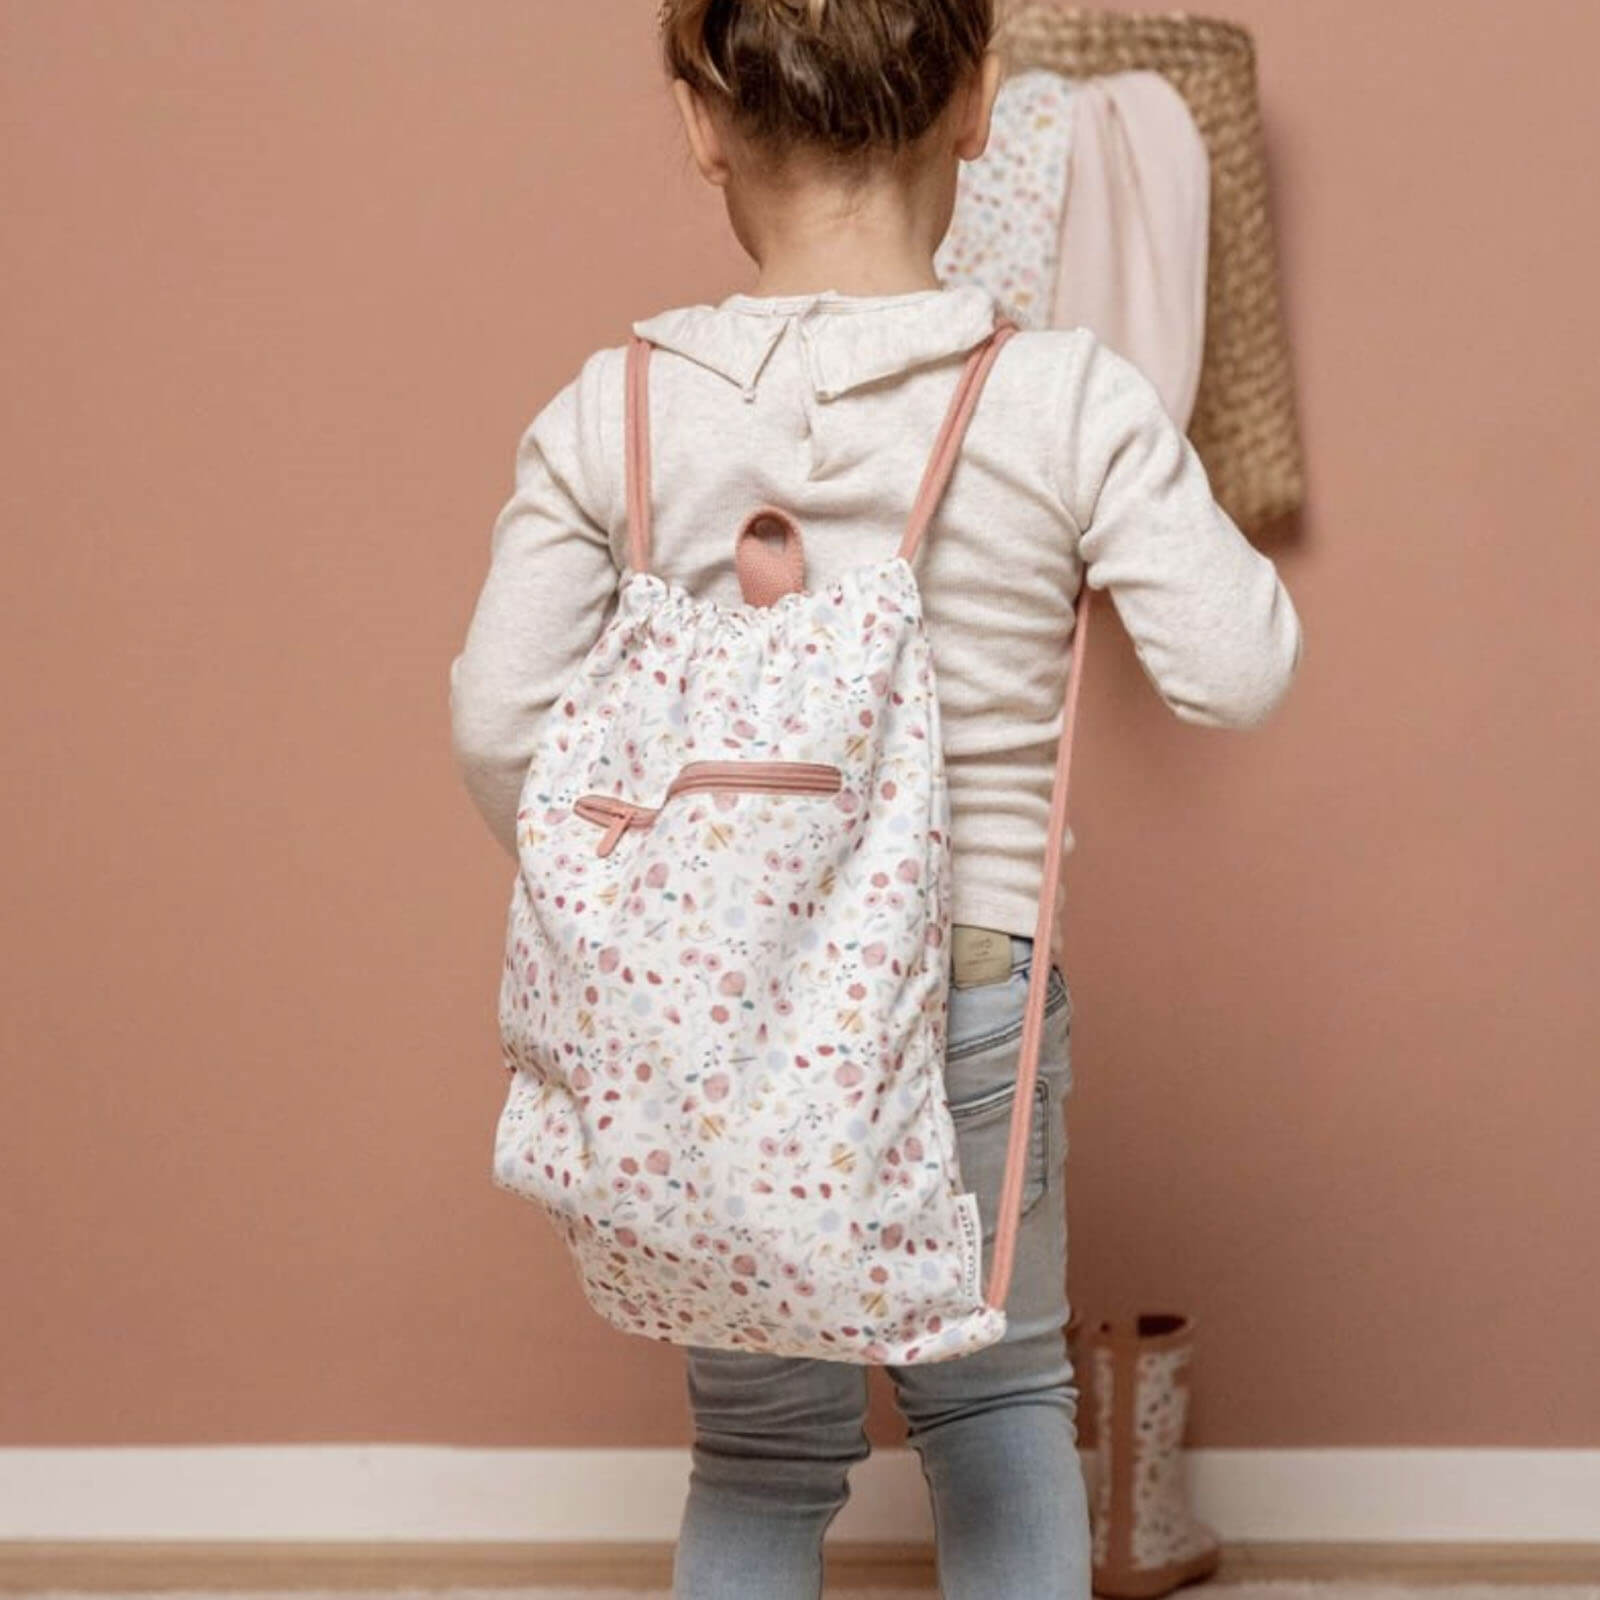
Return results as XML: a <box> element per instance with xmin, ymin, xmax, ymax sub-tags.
<box><xmin>1061</xmin><ymin>334</ymin><xmax>1302</xmax><ymax>728</ymax></box>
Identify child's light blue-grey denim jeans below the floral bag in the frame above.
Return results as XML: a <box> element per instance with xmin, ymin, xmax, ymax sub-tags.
<box><xmin>672</xmin><ymin>934</ymin><xmax>1090</xmax><ymax>1600</ymax></box>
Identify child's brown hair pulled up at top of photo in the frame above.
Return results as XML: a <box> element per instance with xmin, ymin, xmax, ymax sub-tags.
<box><xmin>659</xmin><ymin>0</ymin><xmax>995</xmax><ymax>168</ymax></box>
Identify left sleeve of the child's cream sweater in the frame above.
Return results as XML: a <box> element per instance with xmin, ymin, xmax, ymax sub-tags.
<box><xmin>450</xmin><ymin>350</ymin><xmax>621</xmax><ymax>858</ymax></box>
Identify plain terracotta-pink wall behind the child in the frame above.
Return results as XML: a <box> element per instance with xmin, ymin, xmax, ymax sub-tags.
<box><xmin>0</xmin><ymin>0</ymin><xmax>1600</xmax><ymax>1446</ymax></box>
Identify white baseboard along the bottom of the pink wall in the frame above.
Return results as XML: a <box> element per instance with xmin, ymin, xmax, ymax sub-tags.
<box><xmin>0</xmin><ymin>1445</ymin><xmax>1600</xmax><ymax>1544</ymax></box>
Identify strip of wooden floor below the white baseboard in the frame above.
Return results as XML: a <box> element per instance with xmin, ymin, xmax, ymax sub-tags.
<box><xmin>0</xmin><ymin>1542</ymin><xmax>1600</xmax><ymax>1600</ymax></box>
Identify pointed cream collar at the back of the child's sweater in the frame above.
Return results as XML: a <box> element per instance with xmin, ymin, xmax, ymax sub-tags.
<box><xmin>632</xmin><ymin>283</ymin><xmax>997</xmax><ymax>400</ymax></box>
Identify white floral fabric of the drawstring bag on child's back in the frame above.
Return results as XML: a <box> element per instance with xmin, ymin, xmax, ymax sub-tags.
<box><xmin>493</xmin><ymin>557</ymin><xmax>1006</xmax><ymax>1363</ymax></box>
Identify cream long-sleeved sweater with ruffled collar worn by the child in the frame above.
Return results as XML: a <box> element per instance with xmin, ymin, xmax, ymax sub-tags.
<box><xmin>450</xmin><ymin>285</ymin><xmax>1301</xmax><ymax>934</ymax></box>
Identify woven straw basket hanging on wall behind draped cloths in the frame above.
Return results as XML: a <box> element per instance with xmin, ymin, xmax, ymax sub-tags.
<box><xmin>995</xmin><ymin>0</ymin><xmax>1304</xmax><ymax>530</ymax></box>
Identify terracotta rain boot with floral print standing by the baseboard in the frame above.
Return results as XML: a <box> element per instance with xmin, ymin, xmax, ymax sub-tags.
<box><xmin>1086</xmin><ymin>1312</ymin><xmax>1221</xmax><ymax>1600</ymax></box>
